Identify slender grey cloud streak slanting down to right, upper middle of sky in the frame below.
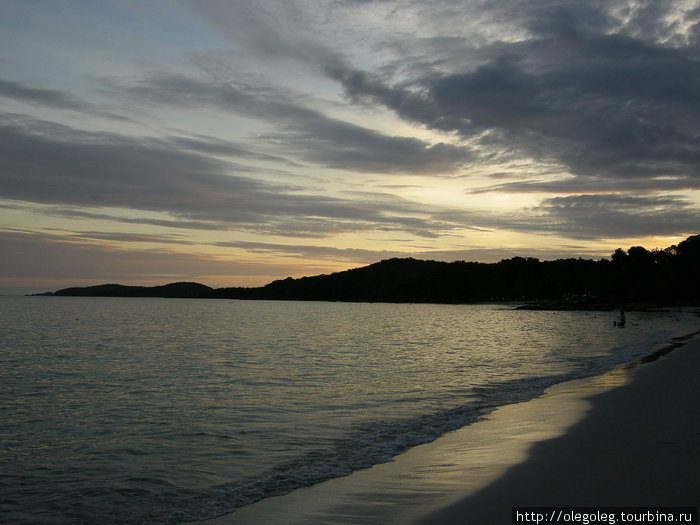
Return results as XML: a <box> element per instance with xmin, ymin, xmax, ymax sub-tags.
<box><xmin>128</xmin><ymin>75</ymin><xmax>474</xmax><ymax>174</ymax></box>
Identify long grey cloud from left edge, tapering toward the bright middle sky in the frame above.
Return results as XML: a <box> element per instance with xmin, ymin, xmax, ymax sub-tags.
<box><xmin>0</xmin><ymin>117</ymin><xmax>470</xmax><ymax>237</ymax></box>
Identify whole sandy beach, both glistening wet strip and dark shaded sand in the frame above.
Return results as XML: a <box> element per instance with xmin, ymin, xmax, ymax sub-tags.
<box><xmin>191</xmin><ymin>336</ymin><xmax>700</xmax><ymax>525</ymax></box>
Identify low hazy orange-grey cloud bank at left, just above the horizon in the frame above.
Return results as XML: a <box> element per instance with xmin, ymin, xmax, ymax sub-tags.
<box><xmin>0</xmin><ymin>230</ymin><xmax>350</xmax><ymax>293</ymax></box>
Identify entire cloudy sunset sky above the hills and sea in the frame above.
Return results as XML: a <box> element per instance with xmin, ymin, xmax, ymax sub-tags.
<box><xmin>0</xmin><ymin>0</ymin><xmax>700</xmax><ymax>293</ymax></box>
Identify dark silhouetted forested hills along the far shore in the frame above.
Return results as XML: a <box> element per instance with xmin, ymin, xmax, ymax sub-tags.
<box><xmin>46</xmin><ymin>235</ymin><xmax>700</xmax><ymax>309</ymax></box>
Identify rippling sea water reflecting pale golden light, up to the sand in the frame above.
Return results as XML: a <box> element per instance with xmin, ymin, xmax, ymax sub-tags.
<box><xmin>0</xmin><ymin>297</ymin><xmax>700</xmax><ymax>523</ymax></box>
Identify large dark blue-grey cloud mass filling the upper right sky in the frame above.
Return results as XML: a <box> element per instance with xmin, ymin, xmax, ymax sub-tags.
<box><xmin>326</xmin><ymin>2</ymin><xmax>700</xmax><ymax>181</ymax></box>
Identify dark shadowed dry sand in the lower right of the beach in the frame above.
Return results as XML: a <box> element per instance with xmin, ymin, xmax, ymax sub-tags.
<box><xmin>414</xmin><ymin>333</ymin><xmax>700</xmax><ymax>525</ymax></box>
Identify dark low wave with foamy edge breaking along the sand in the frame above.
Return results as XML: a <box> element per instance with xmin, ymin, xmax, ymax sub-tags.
<box><xmin>154</xmin><ymin>336</ymin><xmax>691</xmax><ymax>524</ymax></box>
